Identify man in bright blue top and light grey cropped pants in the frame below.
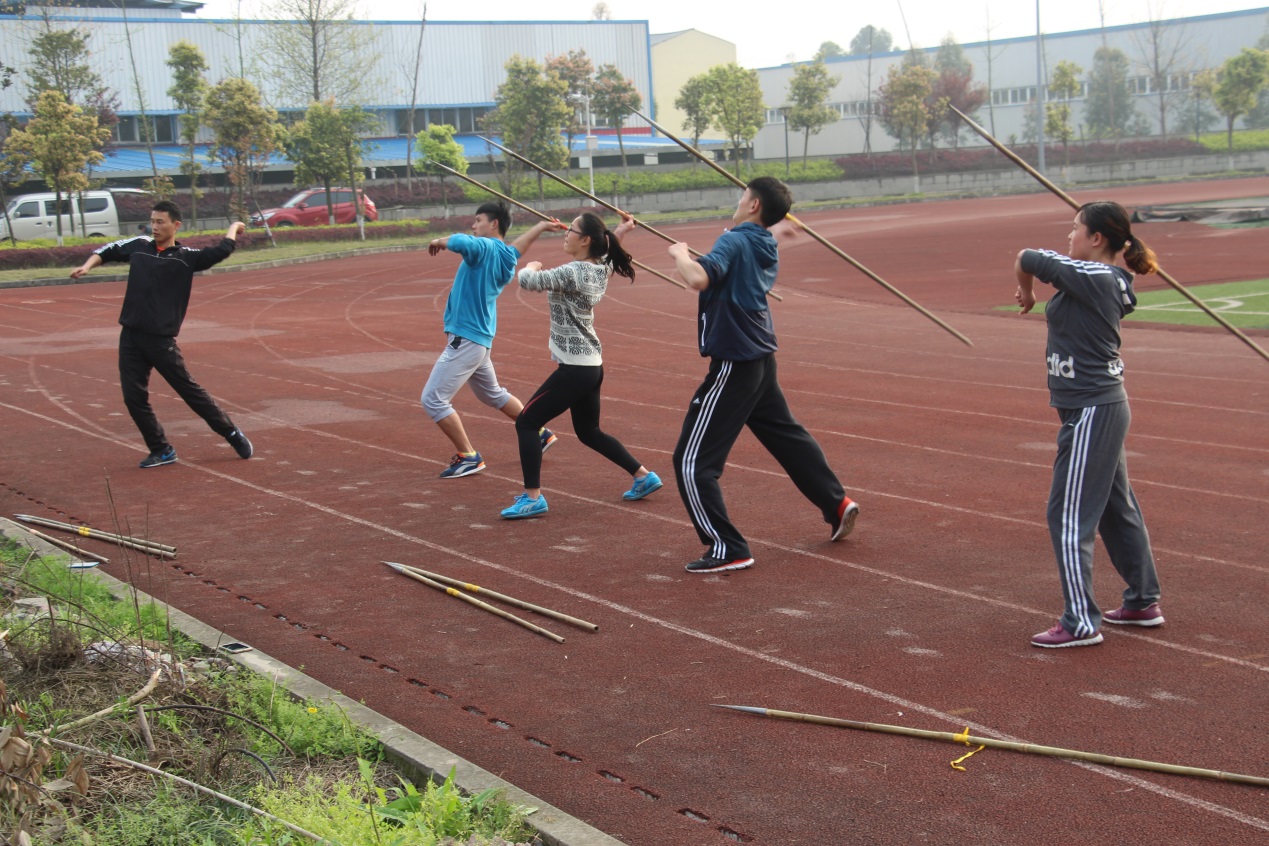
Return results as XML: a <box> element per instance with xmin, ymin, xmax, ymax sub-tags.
<box><xmin>421</xmin><ymin>203</ymin><xmax>560</xmax><ymax>478</ymax></box>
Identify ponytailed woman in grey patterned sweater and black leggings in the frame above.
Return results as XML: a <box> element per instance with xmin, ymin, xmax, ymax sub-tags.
<box><xmin>503</xmin><ymin>212</ymin><xmax>661</xmax><ymax>520</ymax></box>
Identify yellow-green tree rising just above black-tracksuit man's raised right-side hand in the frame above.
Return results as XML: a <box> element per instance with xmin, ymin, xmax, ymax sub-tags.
<box><xmin>203</xmin><ymin>77</ymin><xmax>284</xmax><ymax>221</ymax></box>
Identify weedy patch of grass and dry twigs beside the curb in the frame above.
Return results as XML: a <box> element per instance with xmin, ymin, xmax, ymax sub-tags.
<box><xmin>0</xmin><ymin>539</ymin><xmax>532</xmax><ymax>846</ymax></box>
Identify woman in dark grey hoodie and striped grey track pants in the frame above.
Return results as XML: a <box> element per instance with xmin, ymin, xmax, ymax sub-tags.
<box><xmin>1014</xmin><ymin>203</ymin><xmax>1164</xmax><ymax>649</ymax></box>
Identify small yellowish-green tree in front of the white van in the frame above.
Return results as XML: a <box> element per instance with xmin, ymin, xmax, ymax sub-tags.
<box><xmin>5</xmin><ymin>91</ymin><xmax>110</xmax><ymax>246</ymax></box>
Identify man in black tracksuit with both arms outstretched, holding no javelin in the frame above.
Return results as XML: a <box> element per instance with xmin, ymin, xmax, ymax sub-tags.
<box><xmin>71</xmin><ymin>200</ymin><xmax>251</xmax><ymax>468</ymax></box>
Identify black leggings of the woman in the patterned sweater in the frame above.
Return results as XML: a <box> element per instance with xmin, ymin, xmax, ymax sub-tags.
<box><xmin>515</xmin><ymin>364</ymin><xmax>642</xmax><ymax>490</ymax></box>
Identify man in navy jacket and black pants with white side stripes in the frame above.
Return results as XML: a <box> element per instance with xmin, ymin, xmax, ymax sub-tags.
<box><xmin>670</xmin><ymin>176</ymin><xmax>859</xmax><ymax>573</ymax></box>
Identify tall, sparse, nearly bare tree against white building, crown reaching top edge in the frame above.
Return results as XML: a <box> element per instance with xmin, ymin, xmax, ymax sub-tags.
<box><xmin>261</xmin><ymin>0</ymin><xmax>379</xmax><ymax>105</ymax></box>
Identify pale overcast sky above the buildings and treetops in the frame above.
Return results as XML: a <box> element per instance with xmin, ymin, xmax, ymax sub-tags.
<box><xmin>190</xmin><ymin>0</ymin><xmax>1269</xmax><ymax>67</ymax></box>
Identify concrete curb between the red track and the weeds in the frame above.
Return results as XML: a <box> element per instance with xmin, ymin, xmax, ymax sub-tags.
<box><xmin>0</xmin><ymin>517</ymin><xmax>622</xmax><ymax>846</ymax></box>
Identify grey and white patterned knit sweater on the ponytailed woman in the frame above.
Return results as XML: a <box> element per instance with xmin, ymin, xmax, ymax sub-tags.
<box><xmin>519</xmin><ymin>261</ymin><xmax>610</xmax><ymax>367</ymax></box>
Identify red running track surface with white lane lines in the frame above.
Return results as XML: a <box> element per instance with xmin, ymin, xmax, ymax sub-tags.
<box><xmin>0</xmin><ymin>179</ymin><xmax>1269</xmax><ymax>846</ymax></box>
